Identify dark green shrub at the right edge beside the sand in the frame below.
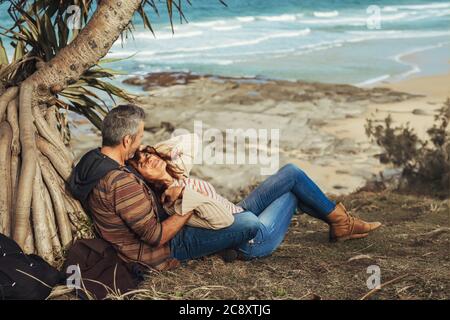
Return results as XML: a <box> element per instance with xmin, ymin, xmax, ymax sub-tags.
<box><xmin>365</xmin><ymin>99</ymin><xmax>450</xmax><ymax>196</ymax></box>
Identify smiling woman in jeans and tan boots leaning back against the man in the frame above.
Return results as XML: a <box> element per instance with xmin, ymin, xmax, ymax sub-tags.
<box><xmin>130</xmin><ymin>136</ymin><xmax>381</xmax><ymax>259</ymax></box>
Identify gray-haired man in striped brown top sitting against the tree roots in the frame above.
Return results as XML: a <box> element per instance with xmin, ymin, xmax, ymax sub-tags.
<box><xmin>69</xmin><ymin>104</ymin><xmax>259</xmax><ymax>270</ymax></box>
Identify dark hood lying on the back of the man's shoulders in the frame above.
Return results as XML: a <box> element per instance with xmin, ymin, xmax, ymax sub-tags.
<box><xmin>69</xmin><ymin>148</ymin><xmax>120</xmax><ymax>207</ymax></box>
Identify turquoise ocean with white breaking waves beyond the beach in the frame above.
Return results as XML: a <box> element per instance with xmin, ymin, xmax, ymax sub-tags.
<box><xmin>0</xmin><ymin>0</ymin><xmax>450</xmax><ymax>86</ymax></box>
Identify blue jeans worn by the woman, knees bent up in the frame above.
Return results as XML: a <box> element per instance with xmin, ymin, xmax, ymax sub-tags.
<box><xmin>238</xmin><ymin>164</ymin><xmax>336</xmax><ymax>259</ymax></box>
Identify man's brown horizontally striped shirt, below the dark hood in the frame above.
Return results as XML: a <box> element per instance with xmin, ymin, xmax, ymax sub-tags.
<box><xmin>88</xmin><ymin>167</ymin><xmax>177</xmax><ymax>270</ymax></box>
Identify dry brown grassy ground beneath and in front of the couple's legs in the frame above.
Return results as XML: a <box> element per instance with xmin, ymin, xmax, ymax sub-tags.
<box><xmin>134</xmin><ymin>191</ymin><xmax>450</xmax><ymax>299</ymax></box>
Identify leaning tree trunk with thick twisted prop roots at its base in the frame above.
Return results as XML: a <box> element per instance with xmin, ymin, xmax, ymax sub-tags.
<box><xmin>0</xmin><ymin>0</ymin><xmax>142</xmax><ymax>263</ymax></box>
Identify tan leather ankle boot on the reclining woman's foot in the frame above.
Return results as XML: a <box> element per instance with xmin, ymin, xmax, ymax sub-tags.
<box><xmin>327</xmin><ymin>203</ymin><xmax>381</xmax><ymax>241</ymax></box>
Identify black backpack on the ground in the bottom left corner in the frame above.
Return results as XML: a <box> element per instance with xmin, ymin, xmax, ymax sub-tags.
<box><xmin>0</xmin><ymin>233</ymin><xmax>66</xmax><ymax>300</ymax></box>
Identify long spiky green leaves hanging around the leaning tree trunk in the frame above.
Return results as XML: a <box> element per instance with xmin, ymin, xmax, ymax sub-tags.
<box><xmin>0</xmin><ymin>0</ymin><xmax>224</xmax><ymax>128</ymax></box>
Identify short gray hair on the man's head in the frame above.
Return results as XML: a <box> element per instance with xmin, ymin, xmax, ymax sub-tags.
<box><xmin>102</xmin><ymin>104</ymin><xmax>145</xmax><ymax>147</ymax></box>
